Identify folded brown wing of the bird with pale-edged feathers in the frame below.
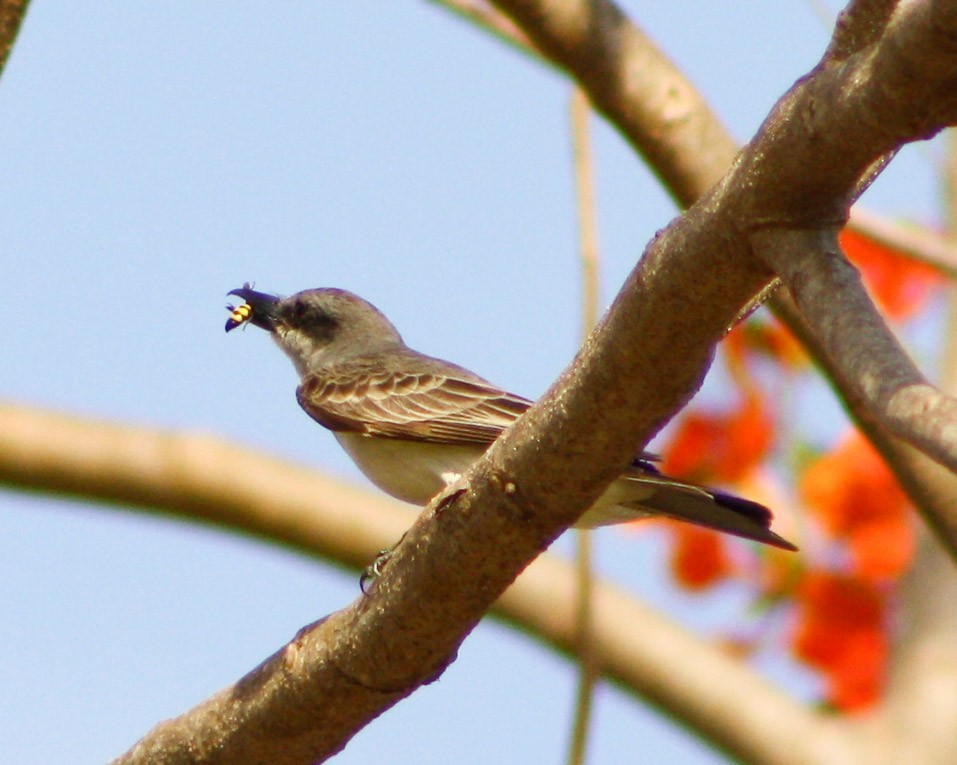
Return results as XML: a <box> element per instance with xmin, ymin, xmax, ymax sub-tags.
<box><xmin>296</xmin><ymin>369</ymin><xmax>531</xmax><ymax>446</ymax></box>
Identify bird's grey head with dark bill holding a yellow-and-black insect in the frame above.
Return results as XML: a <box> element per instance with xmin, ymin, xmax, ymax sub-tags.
<box><xmin>226</xmin><ymin>284</ymin><xmax>402</xmax><ymax>376</ymax></box>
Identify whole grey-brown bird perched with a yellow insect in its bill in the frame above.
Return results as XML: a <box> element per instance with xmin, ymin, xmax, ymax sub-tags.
<box><xmin>226</xmin><ymin>284</ymin><xmax>797</xmax><ymax>550</ymax></box>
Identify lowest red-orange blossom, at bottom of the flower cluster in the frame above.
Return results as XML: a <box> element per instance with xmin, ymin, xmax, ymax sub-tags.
<box><xmin>793</xmin><ymin>571</ymin><xmax>888</xmax><ymax>711</ymax></box>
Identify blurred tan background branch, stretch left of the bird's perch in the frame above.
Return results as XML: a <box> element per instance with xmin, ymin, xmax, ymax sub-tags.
<box><xmin>0</xmin><ymin>404</ymin><xmax>414</xmax><ymax>568</ymax></box>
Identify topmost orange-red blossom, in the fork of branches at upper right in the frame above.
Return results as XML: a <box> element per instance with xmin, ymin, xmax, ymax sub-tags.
<box><xmin>840</xmin><ymin>229</ymin><xmax>941</xmax><ymax>320</ymax></box>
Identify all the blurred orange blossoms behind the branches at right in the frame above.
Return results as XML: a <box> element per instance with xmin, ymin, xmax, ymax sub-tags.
<box><xmin>663</xmin><ymin>231</ymin><xmax>939</xmax><ymax>712</ymax></box>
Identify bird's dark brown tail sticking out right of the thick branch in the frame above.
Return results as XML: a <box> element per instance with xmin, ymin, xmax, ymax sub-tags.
<box><xmin>578</xmin><ymin>470</ymin><xmax>797</xmax><ymax>551</ymax></box>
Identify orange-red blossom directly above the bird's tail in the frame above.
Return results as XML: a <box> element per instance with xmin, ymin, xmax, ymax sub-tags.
<box><xmin>663</xmin><ymin>393</ymin><xmax>774</xmax><ymax>483</ymax></box>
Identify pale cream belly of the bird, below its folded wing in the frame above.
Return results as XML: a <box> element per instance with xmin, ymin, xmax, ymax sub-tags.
<box><xmin>335</xmin><ymin>433</ymin><xmax>484</xmax><ymax>505</ymax></box>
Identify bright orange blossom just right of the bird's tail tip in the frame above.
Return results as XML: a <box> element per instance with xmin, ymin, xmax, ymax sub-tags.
<box><xmin>799</xmin><ymin>430</ymin><xmax>915</xmax><ymax>581</ymax></box>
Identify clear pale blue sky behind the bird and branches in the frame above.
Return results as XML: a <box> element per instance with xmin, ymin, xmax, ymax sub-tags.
<box><xmin>0</xmin><ymin>0</ymin><xmax>937</xmax><ymax>765</ymax></box>
